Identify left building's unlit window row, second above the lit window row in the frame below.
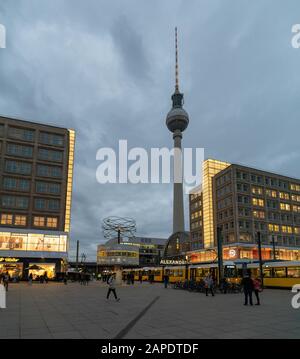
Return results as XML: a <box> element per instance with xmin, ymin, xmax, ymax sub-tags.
<box><xmin>2</xmin><ymin>177</ymin><xmax>61</xmax><ymax>195</ymax></box>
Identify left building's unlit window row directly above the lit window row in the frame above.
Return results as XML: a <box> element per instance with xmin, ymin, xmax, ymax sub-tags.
<box><xmin>1</xmin><ymin>195</ymin><xmax>60</xmax><ymax>211</ymax></box>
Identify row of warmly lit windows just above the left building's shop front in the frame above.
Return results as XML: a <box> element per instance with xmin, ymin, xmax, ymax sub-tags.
<box><xmin>0</xmin><ymin>213</ymin><xmax>58</xmax><ymax>228</ymax></box>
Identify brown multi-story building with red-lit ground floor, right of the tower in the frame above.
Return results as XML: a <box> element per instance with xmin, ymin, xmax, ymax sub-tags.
<box><xmin>189</xmin><ymin>160</ymin><xmax>300</xmax><ymax>262</ymax></box>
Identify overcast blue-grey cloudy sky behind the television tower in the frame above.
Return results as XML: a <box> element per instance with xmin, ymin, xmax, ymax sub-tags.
<box><xmin>0</xmin><ymin>0</ymin><xmax>300</xmax><ymax>260</ymax></box>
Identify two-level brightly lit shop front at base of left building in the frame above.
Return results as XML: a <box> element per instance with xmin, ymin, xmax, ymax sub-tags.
<box><xmin>0</xmin><ymin>228</ymin><xmax>68</xmax><ymax>280</ymax></box>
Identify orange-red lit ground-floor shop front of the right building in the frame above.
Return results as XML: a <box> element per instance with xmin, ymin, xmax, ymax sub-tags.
<box><xmin>188</xmin><ymin>245</ymin><xmax>300</xmax><ymax>263</ymax></box>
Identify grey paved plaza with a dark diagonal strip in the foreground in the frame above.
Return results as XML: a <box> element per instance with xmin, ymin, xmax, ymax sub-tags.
<box><xmin>0</xmin><ymin>282</ymin><xmax>300</xmax><ymax>339</ymax></box>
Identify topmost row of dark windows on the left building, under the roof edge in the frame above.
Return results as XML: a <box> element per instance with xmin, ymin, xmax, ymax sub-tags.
<box><xmin>0</xmin><ymin>124</ymin><xmax>64</xmax><ymax>147</ymax></box>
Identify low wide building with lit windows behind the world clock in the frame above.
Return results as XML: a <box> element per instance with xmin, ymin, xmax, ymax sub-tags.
<box><xmin>97</xmin><ymin>237</ymin><xmax>167</xmax><ymax>269</ymax></box>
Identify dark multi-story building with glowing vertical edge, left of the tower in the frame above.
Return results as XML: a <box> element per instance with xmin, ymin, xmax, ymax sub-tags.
<box><xmin>0</xmin><ymin>117</ymin><xmax>75</xmax><ymax>278</ymax></box>
